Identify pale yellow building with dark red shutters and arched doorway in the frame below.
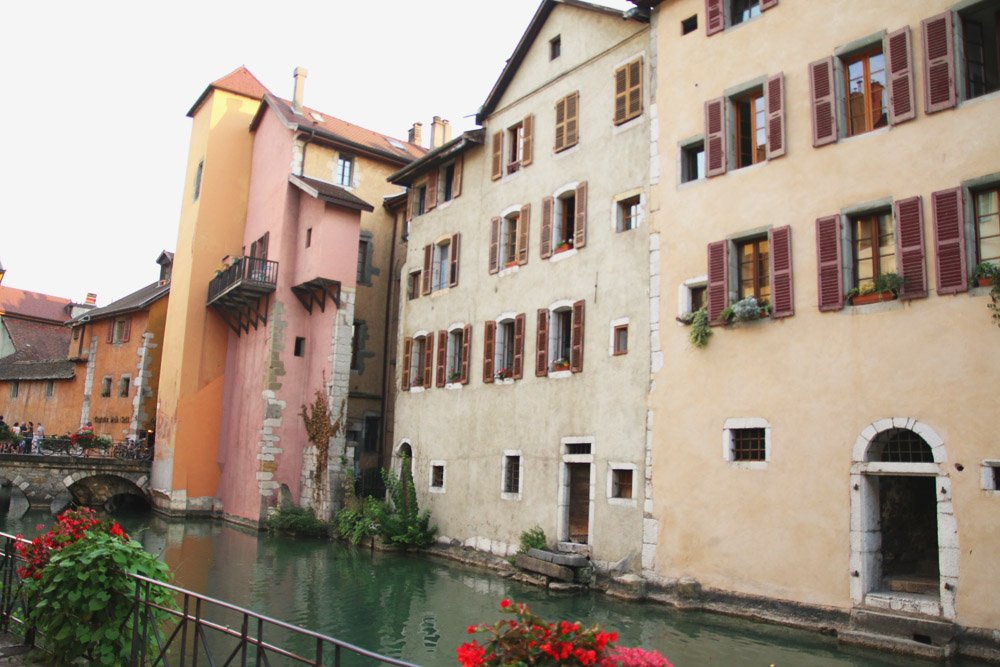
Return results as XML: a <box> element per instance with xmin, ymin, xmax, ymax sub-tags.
<box><xmin>636</xmin><ymin>0</ymin><xmax>1000</xmax><ymax>658</ymax></box>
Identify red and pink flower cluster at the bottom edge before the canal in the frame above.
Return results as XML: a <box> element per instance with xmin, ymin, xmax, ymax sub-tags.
<box><xmin>456</xmin><ymin>600</ymin><xmax>670</xmax><ymax>667</ymax></box>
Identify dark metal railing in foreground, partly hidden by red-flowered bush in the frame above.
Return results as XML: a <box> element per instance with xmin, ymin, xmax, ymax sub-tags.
<box><xmin>0</xmin><ymin>533</ymin><xmax>417</xmax><ymax>667</ymax></box>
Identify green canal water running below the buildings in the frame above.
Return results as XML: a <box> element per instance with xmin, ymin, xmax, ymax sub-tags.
<box><xmin>0</xmin><ymin>497</ymin><xmax>979</xmax><ymax>667</ymax></box>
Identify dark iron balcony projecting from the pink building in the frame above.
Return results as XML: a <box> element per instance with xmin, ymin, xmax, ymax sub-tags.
<box><xmin>207</xmin><ymin>257</ymin><xmax>278</xmax><ymax>335</ymax></box>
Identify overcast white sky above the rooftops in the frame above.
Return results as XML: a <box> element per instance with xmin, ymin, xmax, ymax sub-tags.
<box><xmin>0</xmin><ymin>0</ymin><xmax>632</xmax><ymax>306</ymax></box>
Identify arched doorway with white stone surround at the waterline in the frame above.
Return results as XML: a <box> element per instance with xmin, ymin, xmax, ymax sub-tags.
<box><xmin>851</xmin><ymin>418</ymin><xmax>958</xmax><ymax>619</ymax></box>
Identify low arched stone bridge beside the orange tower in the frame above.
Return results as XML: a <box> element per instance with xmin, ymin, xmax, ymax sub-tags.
<box><xmin>0</xmin><ymin>454</ymin><xmax>152</xmax><ymax>508</ymax></box>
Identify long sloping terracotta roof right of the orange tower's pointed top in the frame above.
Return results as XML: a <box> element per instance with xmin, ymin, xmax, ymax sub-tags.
<box><xmin>250</xmin><ymin>94</ymin><xmax>427</xmax><ymax>164</ymax></box>
